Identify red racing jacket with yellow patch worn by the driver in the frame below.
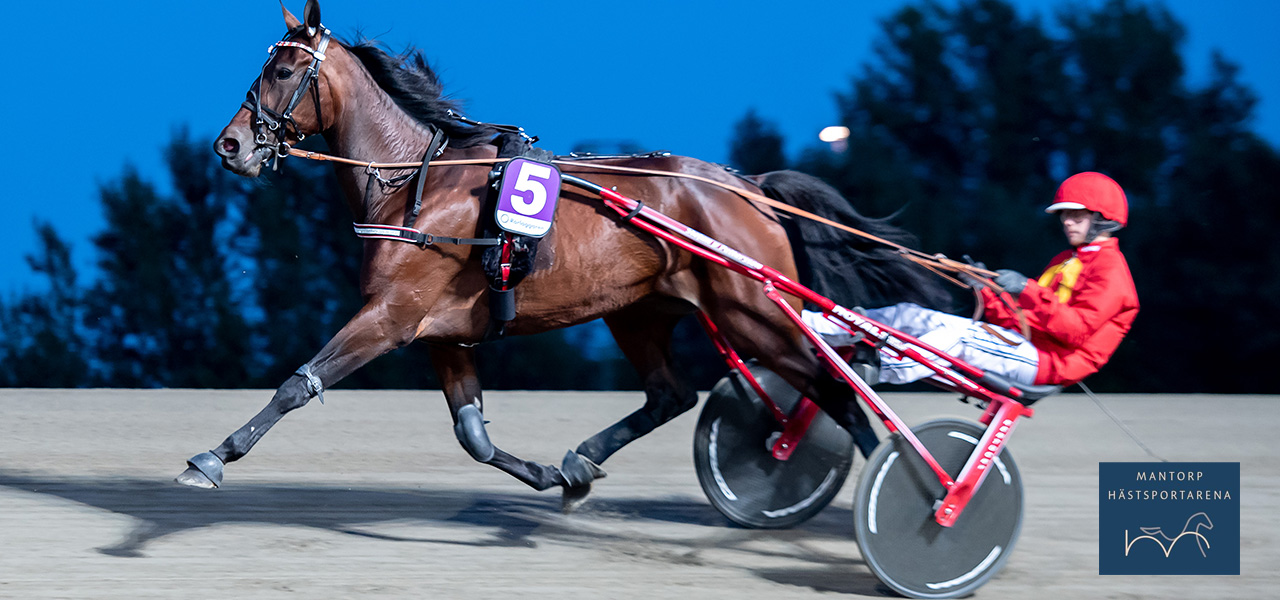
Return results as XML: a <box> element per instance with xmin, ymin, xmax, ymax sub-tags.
<box><xmin>982</xmin><ymin>238</ymin><xmax>1138</xmax><ymax>385</ymax></box>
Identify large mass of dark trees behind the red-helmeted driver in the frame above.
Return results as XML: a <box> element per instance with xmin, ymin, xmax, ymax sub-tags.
<box><xmin>800</xmin><ymin>0</ymin><xmax>1280</xmax><ymax>391</ymax></box>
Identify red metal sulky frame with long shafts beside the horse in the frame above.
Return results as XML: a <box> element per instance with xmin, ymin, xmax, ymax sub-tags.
<box><xmin>563</xmin><ymin>175</ymin><xmax>1034</xmax><ymax>527</ymax></box>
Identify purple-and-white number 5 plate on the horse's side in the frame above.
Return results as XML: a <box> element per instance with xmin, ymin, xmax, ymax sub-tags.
<box><xmin>493</xmin><ymin>159</ymin><xmax>561</xmax><ymax>238</ymax></box>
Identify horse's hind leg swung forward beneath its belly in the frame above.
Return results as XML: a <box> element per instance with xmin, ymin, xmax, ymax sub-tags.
<box><xmin>561</xmin><ymin>306</ymin><xmax>698</xmax><ymax>510</ymax></box>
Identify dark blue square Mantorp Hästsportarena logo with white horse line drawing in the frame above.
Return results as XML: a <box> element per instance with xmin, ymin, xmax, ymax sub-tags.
<box><xmin>1098</xmin><ymin>463</ymin><xmax>1240</xmax><ymax>574</ymax></box>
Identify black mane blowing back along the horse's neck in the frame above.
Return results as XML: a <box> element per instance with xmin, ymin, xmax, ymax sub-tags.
<box><xmin>342</xmin><ymin>41</ymin><xmax>498</xmax><ymax>148</ymax></box>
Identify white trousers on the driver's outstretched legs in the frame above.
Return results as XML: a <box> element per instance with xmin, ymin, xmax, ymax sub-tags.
<box><xmin>801</xmin><ymin>302</ymin><xmax>1039</xmax><ymax>384</ymax></box>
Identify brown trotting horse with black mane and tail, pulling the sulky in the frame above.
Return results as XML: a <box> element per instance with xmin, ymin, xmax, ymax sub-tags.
<box><xmin>177</xmin><ymin>0</ymin><xmax>938</xmax><ymax>508</ymax></box>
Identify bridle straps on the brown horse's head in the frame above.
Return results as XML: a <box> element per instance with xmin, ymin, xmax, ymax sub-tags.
<box><xmin>241</xmin><ymin>26</ymin><xmax>332</xmax><ymax>168</ymax></box>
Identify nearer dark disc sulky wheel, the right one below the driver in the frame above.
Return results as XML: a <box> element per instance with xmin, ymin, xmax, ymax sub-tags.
<box><xmin>854</xmin><ymin>418</ymin><xmax>1023</xmax><ymax>597</ymax></box>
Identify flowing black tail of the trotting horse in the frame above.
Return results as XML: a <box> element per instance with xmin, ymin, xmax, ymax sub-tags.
<box><xmin>751</xmin><ymin>171</ymin><xmax>951</xmax><ymax>311</ymax></box>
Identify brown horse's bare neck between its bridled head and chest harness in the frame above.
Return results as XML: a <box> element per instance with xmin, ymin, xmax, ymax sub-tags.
<box><xmin>324</xmin><ymin>56</ymin><xmax>431</xmax><ymax>225</ymax></box>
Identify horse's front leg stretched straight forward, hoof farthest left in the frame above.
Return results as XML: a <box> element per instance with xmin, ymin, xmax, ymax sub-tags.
<box><xmin>177</xmin><ymin>302</ymin><xmax>422</xmax><ymax>487</ymax></box>
